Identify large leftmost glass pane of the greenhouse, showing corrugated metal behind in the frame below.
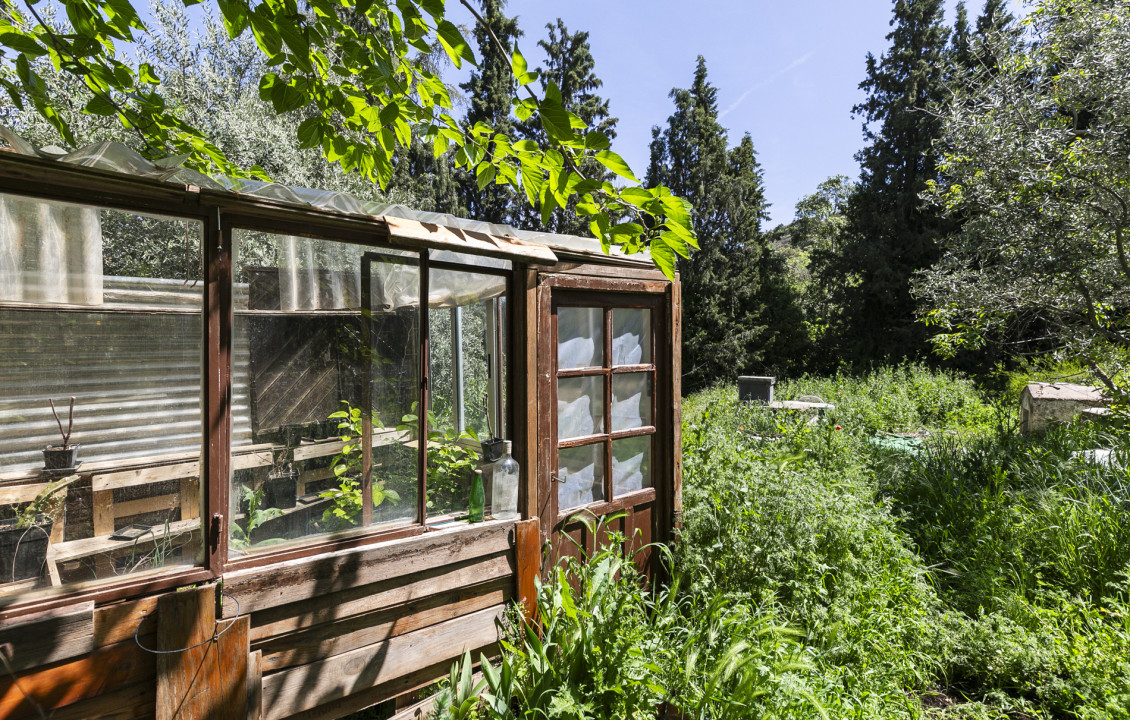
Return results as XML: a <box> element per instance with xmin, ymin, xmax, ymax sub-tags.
<box><xmin>0</xmin><ymin>194</ymin><xmax>203</xmax><ymax>601</ymax></box>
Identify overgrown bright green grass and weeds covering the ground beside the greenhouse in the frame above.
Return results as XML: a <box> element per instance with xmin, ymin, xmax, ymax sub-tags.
<box><xmin>429</xmin><ymin>366</ymin><xmax>1130</xmax><ymax>720</ymax></box>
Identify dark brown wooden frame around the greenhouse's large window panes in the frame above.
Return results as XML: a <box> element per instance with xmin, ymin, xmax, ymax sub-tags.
<box><xmin>0</xmin><ymin>160</ymin><xmax>519</xmax><ymax>621</ymax></box>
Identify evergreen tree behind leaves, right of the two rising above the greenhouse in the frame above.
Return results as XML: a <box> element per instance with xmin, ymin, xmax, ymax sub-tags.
<box><xmin>514</xmin><ymin>18</ymin><xmax>616</xmax><ymax>235</ymax></box>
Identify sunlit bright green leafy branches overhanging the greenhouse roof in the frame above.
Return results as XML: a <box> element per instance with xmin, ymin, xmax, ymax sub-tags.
<box><xmin>0</xmin><ymin>0</ymin><xmax>697</xmax><ymax>277</ymax></box>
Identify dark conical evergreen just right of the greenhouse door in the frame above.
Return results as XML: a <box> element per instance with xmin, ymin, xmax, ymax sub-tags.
<box><xmin>647</xmin><ymin>57</ymin><xmax>799</xmax><ymax>388</ymax></box>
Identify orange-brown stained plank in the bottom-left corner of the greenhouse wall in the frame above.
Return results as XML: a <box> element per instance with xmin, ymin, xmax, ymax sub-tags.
<box><xmin>0</xmin><ymin>640</ymin><xmax>156</xmax><ymax>718</ymax></box>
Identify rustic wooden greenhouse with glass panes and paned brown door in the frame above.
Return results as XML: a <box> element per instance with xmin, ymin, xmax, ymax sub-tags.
<box><xmin>0</xmin><ymin>129</ymin><xmax>680</xmax><ymax>718</ymax></box>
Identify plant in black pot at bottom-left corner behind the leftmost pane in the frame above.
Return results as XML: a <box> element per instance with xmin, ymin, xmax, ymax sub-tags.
<box><xmin>0</xmin><ymin>475</ymin><xmax>79</xmax><ymax>583</ymax></box>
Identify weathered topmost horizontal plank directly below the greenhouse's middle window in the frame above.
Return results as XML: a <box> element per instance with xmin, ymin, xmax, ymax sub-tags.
<box><xmin>224</xmin><ymin>521</ymin><xmax>513</xmax><ymax>615</ymax></box>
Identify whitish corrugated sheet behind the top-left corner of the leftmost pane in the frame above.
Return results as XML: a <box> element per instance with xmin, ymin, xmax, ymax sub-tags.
<box><xmin>0</xmin><ymin>196</ymin><xmax>103</xmax><ymax>305</ymax></box>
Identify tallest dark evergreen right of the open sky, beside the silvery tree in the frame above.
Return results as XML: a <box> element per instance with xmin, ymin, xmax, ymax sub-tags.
<box><xmin>829</xmin><ymin>0</ymin><xmax>949</xmax><ymax>363</ymax></box>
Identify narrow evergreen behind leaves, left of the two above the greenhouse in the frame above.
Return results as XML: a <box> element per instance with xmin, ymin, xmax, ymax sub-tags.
<box><xmin>459</xmin><ymin>0</ymin><xmax>524</xmax><ymax>223</ymax></box>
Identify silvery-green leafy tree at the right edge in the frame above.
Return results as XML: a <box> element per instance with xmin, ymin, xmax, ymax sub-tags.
<box><xmin>915</xmin><ymin>0</ymin><xmax>1130</xmax><ymax>386</ymax></box>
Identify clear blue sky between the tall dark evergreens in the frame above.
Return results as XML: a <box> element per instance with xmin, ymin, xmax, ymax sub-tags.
<box><xmin>447</xmin><ymin>0</ymin><xmax>981</xmax><ymax>226</ymax></box>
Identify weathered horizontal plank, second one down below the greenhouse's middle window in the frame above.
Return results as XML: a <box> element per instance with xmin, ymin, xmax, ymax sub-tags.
<box><xmin>247</xmin><ymin>553</ymin><xmax>514</xmax><ymax>643</ymax></box>
